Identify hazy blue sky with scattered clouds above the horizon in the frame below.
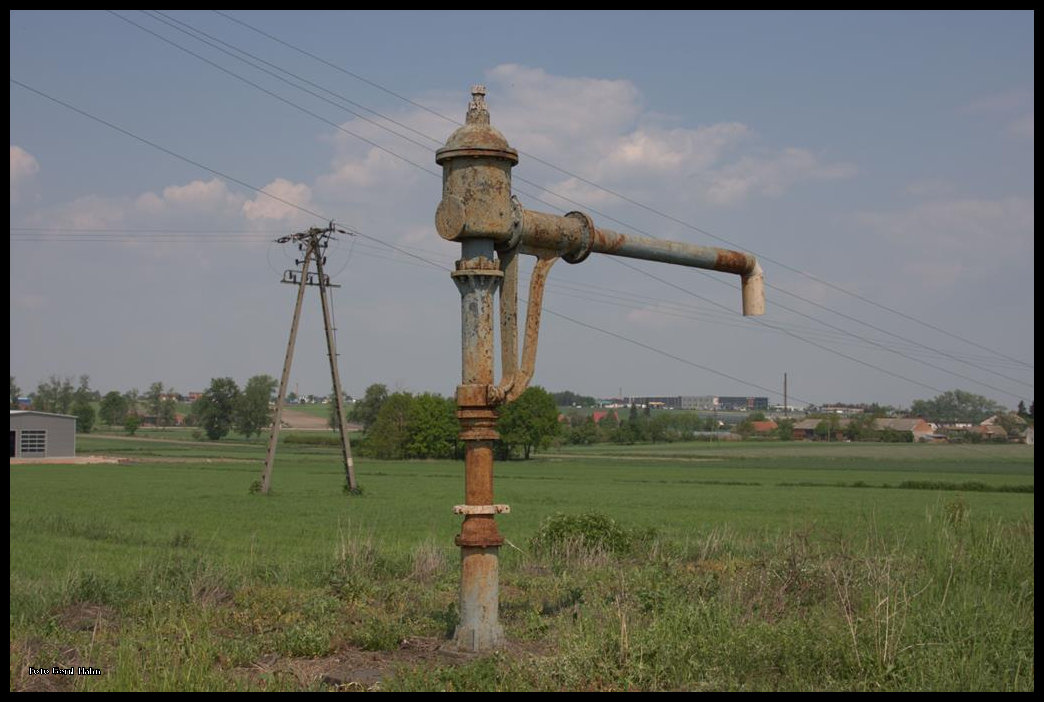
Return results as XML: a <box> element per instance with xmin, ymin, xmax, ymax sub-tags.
<box><xmin>9</xmin><ymin>10</ymin><xmax>1034</xmax><ymax>408</ymax></box>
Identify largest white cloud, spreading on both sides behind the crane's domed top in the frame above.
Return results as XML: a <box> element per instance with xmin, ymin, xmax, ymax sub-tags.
<box><xmin>304</xmin><ymin>64</ymin><xmax>855</xmax><ymax>228</ymax></box>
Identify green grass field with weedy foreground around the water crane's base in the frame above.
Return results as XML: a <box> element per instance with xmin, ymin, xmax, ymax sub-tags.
<box><xmin>10</xmin><ymin>436</ymin><xmax>1034</xmax><ymax>691</ymax></box>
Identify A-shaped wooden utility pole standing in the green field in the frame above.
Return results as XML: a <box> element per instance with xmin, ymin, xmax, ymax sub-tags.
<box><xmin>261</xmin><ymin>221</ymin><xmax>359</xmax><ymax>495</ymax></box>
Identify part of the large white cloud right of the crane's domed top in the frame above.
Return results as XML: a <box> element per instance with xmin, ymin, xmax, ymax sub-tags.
<box><xmin>488</xmin><ymin>65</ymin><xmax>855</xmax><ymax>205</ymax></box>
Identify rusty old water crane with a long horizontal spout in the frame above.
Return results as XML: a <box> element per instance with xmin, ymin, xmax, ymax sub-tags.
<box><xmin>435</xmin><ymin>86</ymin><xmax>765</xmax><ymax>652</ymax></box>
